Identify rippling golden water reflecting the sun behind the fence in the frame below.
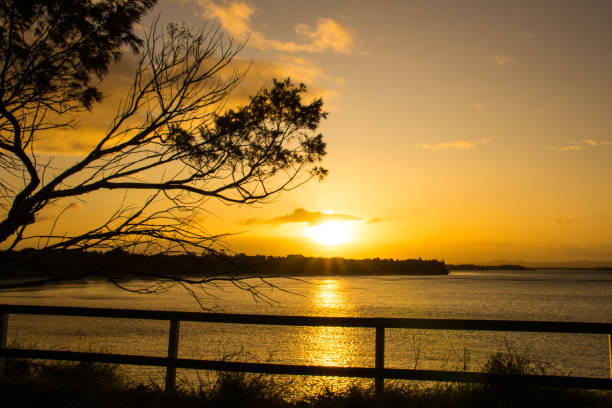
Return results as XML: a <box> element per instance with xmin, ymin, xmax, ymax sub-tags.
<box><xmin>0</xmin><ymin>270</ymin><xmax>612</xmax><ymax>392</ymax></box>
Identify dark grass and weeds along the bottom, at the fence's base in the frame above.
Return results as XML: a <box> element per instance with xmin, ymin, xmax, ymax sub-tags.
<box><xmin>0</xmin><ymin>350</ymin><xmax>612</xmax><ymax>408</ymax></box>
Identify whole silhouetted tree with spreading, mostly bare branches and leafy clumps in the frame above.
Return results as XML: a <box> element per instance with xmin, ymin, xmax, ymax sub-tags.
<box><xmin>0</xmin><ymin>0</ymin><xmax>326</xmax><ymax>294</ymax></box>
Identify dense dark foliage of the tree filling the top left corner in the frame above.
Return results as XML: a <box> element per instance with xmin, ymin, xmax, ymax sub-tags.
<box><xmin>0</xmin><ymin>0</ymin><xmax>156</xmax><ymax>113</ymax></box>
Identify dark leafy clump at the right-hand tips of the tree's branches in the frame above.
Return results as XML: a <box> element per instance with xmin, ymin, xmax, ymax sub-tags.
<box><xmin>170</xmin><ymin>78</ymin><xmax>327</xmax><ymax>179</ymax></box>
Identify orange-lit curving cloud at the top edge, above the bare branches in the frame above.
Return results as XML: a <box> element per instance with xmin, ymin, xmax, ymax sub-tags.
<box><xmin>199</xmin><ymin>0</ymin><xmax>356</xmax><ymax>54</ymax></box>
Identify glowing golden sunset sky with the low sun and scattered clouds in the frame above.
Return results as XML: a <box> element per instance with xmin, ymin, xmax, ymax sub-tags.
<box><xmin>39</xmin><ymin>0</ymin><xmax>612</xmax><ymax>263</ymax></box>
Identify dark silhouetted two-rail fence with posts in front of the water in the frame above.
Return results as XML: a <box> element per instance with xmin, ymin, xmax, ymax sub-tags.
<box><xmin>0</xmin><ymin>305</ymin><xmax>612</xmax><ymax>396</ymax></box>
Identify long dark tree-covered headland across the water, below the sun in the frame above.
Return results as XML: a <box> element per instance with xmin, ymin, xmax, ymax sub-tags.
<box><xmin>0</xmin><ymin>249</ymin><xmax>448</xmax><ymax>289</ymax></box>
